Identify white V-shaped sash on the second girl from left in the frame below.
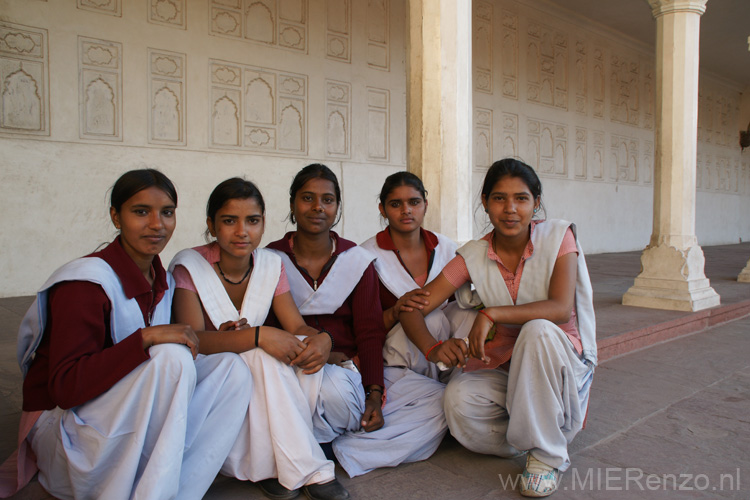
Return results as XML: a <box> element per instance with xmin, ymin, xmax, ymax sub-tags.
<box><xmin>169</xmin><ymin>248</ymin><xmax>281</xmax><ymax>328</ymax></box>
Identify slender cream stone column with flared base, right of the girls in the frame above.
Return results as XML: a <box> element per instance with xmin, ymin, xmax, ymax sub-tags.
<box><xmin>622</xmin><ymin>0</ymin><xmax>719</xmax><ymax>311</ymax></box>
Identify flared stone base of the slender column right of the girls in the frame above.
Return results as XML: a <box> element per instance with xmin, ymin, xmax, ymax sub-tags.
<box><xmin>622</xmin><ymin>244</ymin><xmax>720</xmax><ymax>311</ymax></box>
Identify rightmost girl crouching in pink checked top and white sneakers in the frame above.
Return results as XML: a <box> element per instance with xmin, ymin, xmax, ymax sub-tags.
<box><xmin>399</xmin><ymin>159</ymin><xmax>596</xmax><ymax>497</ymax></box>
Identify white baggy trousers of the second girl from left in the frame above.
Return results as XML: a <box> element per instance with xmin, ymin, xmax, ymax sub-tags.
<box><xmin>221</xmin><ymin>349</ymin><xmax>340</xmax><ymax>490</ymax></box>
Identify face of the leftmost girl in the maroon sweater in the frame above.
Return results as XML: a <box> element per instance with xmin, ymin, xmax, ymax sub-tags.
<box><xmin>110</xmin><ymin>186</ymin><xmax>177</xmax><ymax>269</ymax></box>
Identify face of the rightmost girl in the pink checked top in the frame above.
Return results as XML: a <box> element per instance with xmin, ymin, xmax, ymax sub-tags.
<box><xmin>482</xmin><ymin>175</ymin><xmax>540</xmax><ymax>244</ymax></box>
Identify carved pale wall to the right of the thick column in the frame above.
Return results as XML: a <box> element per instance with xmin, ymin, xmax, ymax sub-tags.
<box><xmin>473</xmin><ymin>0</ymin><xmax>750</xmax><ymax>253</ymax></box>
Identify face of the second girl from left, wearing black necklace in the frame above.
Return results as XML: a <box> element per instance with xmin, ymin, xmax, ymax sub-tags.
<box><xmin>206</xmin><ymin>198</ymin><xmax>265</xmax><ymax>259</ymax></box>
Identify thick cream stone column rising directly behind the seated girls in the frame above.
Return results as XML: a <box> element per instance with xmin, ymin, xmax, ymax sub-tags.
<box><xmin>406</xmin><ymin>0</ymin><xmax>472</xmax><ymax>241</ymax></box>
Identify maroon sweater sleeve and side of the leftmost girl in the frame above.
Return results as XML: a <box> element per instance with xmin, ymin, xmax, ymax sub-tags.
<box><xmin>23</xmin><ymin>281</ymin><xmax>148</xmax><ymax>411</ymax></box>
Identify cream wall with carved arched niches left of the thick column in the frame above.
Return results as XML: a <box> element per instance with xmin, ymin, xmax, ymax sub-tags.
<box><xmin>0</xmin><ymin>0</ymin><xmax>406</xmax><ymax>297</ymax></box>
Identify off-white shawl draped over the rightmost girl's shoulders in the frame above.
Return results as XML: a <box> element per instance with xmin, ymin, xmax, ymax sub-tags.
<box><xmin>456</xmin><ymin>219</ymin><xmax>597</xmax><ymax>365</ymax></box>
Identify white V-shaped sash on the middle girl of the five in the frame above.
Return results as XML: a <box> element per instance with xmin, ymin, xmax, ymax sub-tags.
<box><xmin>271</xmin><ymin>246</ymin><xmax>375</xmax><ymax>316</ymax></box>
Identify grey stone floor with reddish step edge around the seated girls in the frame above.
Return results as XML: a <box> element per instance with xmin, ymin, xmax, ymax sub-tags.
<box><xmin>0</xmin><ymin>243</ymin><xmax>750</xmax><ymax>500</ymax></box>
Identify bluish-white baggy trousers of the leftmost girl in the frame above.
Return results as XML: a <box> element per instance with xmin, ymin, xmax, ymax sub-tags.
<box><xmin>28</xmin><ymin>344</ymin><xmax>252</xmax><ymax>500</ymax></box>
